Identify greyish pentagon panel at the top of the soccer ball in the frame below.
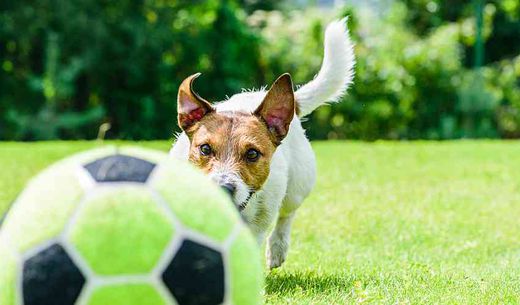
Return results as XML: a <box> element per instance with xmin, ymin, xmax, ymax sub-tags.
<box><xmin>83</xmin><ymin>155</ymin><xmax>155</xmax><ymax>183</ymax></box>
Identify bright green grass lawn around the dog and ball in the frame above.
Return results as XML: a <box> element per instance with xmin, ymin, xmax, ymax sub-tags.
<box><xmin>0</xmin><ymin>141</ymin><xmax>520</xmax><ymax>305</ymax></box>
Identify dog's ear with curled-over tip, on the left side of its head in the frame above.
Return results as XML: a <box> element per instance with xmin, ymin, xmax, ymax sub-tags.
<box><xmin>177</xmin><ymin>73</ymin><xmax>214</xmax><ymax>131</ymax></box>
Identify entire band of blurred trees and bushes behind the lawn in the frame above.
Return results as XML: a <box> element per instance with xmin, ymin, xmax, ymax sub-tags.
<box><xmin>0</xmin><ymin>0</ymin><xmax>520</xmax><ymax>140</ymax></box>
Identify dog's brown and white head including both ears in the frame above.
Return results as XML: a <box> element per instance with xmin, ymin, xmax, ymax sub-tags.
<box><xmin>177</xmin><ymin>74</ymin><xmax>295</xmax><ymax>210</ymax></box>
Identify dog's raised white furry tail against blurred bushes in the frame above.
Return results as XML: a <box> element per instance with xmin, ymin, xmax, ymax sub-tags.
<box><xmin>295</xmin><ymin>18</ymin><xmax>356</xmax><ymax>117</ymax></box>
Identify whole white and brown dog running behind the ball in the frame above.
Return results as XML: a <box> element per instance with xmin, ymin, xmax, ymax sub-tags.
<box><xmin>170</xmin><ymin>18</ymin><xmax>355</xmax><ymax>269</ymax></box>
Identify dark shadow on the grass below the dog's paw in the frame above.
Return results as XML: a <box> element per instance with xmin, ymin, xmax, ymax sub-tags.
<box><xmin>266</xmin><ymin>270</ymin><xmax>359</xmax><ymax>294</ymax></box>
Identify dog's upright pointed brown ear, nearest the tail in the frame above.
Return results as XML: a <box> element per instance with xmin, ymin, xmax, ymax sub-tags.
<box><xmin>255</xmin><ymin>73</ymin><xmax>295</xmax><ymax>144</ymax></box>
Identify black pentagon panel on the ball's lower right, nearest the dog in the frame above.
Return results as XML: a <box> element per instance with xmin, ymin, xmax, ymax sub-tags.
<box><xmin>162</xmin><ymin>240</ymin><xmax>225</xmax><ymax>305</ymax></box>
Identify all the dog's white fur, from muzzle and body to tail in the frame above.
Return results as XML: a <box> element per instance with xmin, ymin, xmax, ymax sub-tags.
<box><xmin>170</xmin><ymin>19</ymin><xmax>355</xmax><ymax>268</ymax></box>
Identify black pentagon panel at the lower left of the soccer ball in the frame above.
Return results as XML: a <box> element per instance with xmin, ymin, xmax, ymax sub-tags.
<box><xmin>22</xmin><ymin>244</ymin><xmax>85</xmax><ymax>305</ymax></box>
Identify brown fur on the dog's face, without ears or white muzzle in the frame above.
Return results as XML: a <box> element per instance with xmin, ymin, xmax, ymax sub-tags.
<box><xmin>187</xmin><ymin>112</ymin><xmax>277</xmax><ymax>191</ymax></box>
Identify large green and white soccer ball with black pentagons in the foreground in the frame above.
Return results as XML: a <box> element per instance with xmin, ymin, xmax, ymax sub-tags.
<box><xmin>0</xmin><ymin>147</ymin><xmax>263</xmax><ymax>305</ymax></box>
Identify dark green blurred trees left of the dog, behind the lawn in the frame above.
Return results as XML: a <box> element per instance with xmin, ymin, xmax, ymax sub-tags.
<box><xmin>0</xmin><ymin>0</ymin><xmax>259</xmax><ymax>140</ymax></box>
